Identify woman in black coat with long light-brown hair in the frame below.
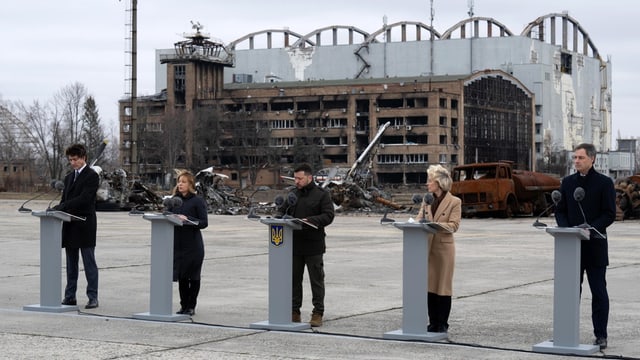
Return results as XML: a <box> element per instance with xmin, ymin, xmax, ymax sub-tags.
<box><xmin>170</xmin><ymin>171</ymin><xmax>208</xmax><ymax>315</ymax></box>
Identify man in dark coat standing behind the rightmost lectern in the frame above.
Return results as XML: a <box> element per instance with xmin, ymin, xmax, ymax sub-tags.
<box><xmin>555</xmin><ymin>144</ymin><xmax>616</xmax><ymax>349</ymax></box>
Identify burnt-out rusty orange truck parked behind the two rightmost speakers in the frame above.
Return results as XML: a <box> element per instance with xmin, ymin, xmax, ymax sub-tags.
<box><xmin>451</xmin><ymin>161</ymin><xmax>560</xmax><ymax>217</ymax></box>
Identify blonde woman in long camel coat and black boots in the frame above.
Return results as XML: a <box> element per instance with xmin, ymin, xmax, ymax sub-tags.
<box><xmin>416</xmin><ymin>165</ymin><xmax>462</xmax><ymax>332</ymax></box>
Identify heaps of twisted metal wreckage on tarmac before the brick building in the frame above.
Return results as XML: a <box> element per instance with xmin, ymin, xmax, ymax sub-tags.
<box><xmin>91</xmin><ymin>122</ymin><xmax>406</xmax><ymax>215</ymax></box>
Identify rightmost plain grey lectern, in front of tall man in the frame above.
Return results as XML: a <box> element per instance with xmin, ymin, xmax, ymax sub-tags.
<box><xmin>533</xmin><ymin>227</ymin><xmax>600</xmax><ymax>355</ymax></box>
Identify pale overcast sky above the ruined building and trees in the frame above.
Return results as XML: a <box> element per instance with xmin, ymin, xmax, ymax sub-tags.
<box><xmin>0</xmin><ymin>0</ymin><xmax>640</xmax><ymax>148</ymax></box>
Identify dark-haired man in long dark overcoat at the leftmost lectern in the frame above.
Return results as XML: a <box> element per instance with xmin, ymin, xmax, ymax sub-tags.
<box><xmin>54</xmin><ymin>144</ymin><xmax>100</xmax><ymax>309</ymax></box>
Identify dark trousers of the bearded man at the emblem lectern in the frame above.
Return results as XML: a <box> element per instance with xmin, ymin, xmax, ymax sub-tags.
<box><xmin>291</xmin><ymin>254</ymin><xmax>324</xmax><ymax>315</ymax></box>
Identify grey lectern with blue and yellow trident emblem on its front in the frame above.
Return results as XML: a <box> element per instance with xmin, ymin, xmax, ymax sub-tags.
<box><xmin>249</xmin><ymin>219</ymin><xmax>311</xmax><ymax>330</ymax></box>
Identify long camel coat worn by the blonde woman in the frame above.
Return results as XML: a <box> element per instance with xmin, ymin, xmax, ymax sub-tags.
<box><xmin>416</xmin><ymin>192</ymin><xmax>462</xmax><ymax>296</ymax></box>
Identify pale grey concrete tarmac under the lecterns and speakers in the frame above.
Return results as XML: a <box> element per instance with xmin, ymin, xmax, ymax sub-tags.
<box><xmin>0</xmin><ymin>200</ymin><xmax>640</xmax><ymax>359</ymax></box>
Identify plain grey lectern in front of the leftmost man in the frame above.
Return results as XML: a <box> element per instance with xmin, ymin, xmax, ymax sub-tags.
<box><xmin>23</xmin><ymin>210</ymin><xmax>84</xmax><ymax>312</ymax></box>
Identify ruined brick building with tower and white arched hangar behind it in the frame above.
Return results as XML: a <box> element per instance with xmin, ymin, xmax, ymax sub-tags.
<box><xmin>120</xmin><ymin>13</ymin><xmax>611</xmax><ymax>187</ymax></box>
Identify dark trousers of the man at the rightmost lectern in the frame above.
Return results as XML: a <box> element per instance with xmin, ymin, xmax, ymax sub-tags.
<box><xmin>580</xmin><ymin>267</ymin><xmax>609</xmax><ymax>338</ymax></box>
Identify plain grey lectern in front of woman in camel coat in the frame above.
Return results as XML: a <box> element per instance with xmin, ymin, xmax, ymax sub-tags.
<box><xmin>383</xmin><ymin>222</ymin><xmax>447</xmax><ymax>341</ymax></box>
